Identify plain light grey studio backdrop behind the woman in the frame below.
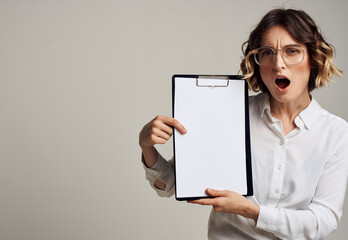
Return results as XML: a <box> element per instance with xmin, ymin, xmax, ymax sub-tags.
<box><xmin>0</xmin><ymin>0</ymin><xmax>348</xmax><ymax>240</ymax></box>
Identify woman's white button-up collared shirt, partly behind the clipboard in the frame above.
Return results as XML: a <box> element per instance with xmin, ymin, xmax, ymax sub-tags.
<box><xmin>144</xmin><ymin>94</ymin><xmax>348</xmax><ymax>239</ymax></box>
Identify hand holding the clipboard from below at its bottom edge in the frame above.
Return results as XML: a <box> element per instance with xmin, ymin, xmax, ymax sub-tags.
<box><xmin>188</xmin><ymin>188</ymin><xmax>260</xmax><ymax>223</ymax></box>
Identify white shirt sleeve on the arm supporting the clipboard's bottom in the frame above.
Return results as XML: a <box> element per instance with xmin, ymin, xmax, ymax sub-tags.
<box><xmin>256</xmin><ymin>136</ymin><xmax>348</xmax><ymax>239</ymax></box>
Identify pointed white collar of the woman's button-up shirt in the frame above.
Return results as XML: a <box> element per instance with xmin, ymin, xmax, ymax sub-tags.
<box><xmin>258</xmin><ymin>93</ymin><xmax>321</xmax><ymax>129</ymax></box>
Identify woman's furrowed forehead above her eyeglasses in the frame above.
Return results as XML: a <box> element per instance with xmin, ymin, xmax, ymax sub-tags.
<box><xmin>261</xmin><ymin>26</ymin><xmax>304</xmax><ymax>48</ymax></box>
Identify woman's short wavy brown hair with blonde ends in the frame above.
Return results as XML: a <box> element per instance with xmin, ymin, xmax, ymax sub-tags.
<box><xmin>240</xmin><ymin>9</ymin><xmax>343</xmax><ymax>92</ymax></box>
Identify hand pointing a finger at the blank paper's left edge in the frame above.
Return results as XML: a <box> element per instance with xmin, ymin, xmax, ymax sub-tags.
<box><xmin>139</xmin><ymin>115</ymin><xmax>187</xmax><ymax>149</ymax></box>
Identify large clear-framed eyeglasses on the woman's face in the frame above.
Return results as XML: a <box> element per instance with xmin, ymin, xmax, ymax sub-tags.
<box><xmin>250</xmin><ymin>45</ymin><xmax>306</xmax><ymax>66</ymax></box>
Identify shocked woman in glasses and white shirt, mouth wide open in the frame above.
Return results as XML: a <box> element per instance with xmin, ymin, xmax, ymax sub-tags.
<box><xmin>139</xmin><ymin>9</ymin><xmax>348</xmax><ymax>239</ymax></box>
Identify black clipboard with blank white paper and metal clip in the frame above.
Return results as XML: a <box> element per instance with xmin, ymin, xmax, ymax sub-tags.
<box><xmin>172</xmin><ymin>75</ymin><xmax>253</xmax><ymax>201</ymax></box>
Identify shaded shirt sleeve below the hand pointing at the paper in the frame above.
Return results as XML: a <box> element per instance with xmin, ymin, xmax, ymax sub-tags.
<box><xmin>141</xmin><ymin>152</ymin><xmax>175</xmax><ymax>197</ymax></box>
